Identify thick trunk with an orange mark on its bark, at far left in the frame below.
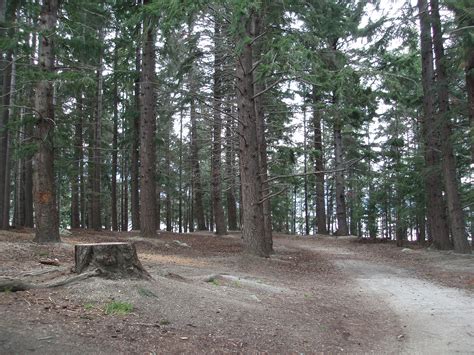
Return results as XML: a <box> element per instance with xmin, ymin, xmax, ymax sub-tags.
<box><xmin>33</xmin><ymin>0</ymin><xmax>60</xmax><ymax>243</ymax></box>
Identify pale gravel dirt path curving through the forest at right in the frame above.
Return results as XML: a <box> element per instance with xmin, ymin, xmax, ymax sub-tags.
<box><xmin>282</xmin><ymin>238</ymin><xmax>474</xmax><ymax>354</ymax></box>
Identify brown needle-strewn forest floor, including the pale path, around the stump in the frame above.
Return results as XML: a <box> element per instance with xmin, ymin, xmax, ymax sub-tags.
<box><xmin>0</xmin><ymin>230</ymin><xmax>474</xmax><ymax>354</ymax></box>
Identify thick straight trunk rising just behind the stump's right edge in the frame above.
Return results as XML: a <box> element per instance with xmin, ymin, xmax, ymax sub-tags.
<box><xmin>140</xmin><ymin>1</ymin><xmax>157</xmax><ymax>237</ymax></box>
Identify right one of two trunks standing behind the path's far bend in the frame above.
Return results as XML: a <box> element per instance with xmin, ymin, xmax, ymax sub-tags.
<box><xmin>333</xmin><ymin>117</ymin><xmax>349</xmax><ymax>235</ymax></box>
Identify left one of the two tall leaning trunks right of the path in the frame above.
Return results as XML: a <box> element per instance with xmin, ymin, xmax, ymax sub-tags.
<box><xmin>418</xmin><ymin>0</ymin><xmax>452</xmax><ymax>250</ymax></box>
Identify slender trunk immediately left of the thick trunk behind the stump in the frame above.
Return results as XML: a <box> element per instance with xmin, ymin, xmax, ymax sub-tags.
<box><xmin>130</xmin><ymin>40</ymin><xmax>141</xmax><ymax>230</ymax></box>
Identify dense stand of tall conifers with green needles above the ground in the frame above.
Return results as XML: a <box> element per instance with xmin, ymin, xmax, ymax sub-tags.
<box><xmin>0</xmin><ymin>0</ymin><xmax>474</xmax><ymax>256</ymax></box>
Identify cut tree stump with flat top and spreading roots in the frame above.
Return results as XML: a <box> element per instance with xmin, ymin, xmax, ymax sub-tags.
<box><xmin>74</xmin><ymin>243</ymin><xmax>151</xmax><ymax>279</ymax></box>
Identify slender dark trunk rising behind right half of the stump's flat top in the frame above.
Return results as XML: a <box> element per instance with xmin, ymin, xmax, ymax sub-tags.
<box><xmin>111</xmin><ymin>43</ymin><xmax>119</xmax><ymax>231</ymax></box>
